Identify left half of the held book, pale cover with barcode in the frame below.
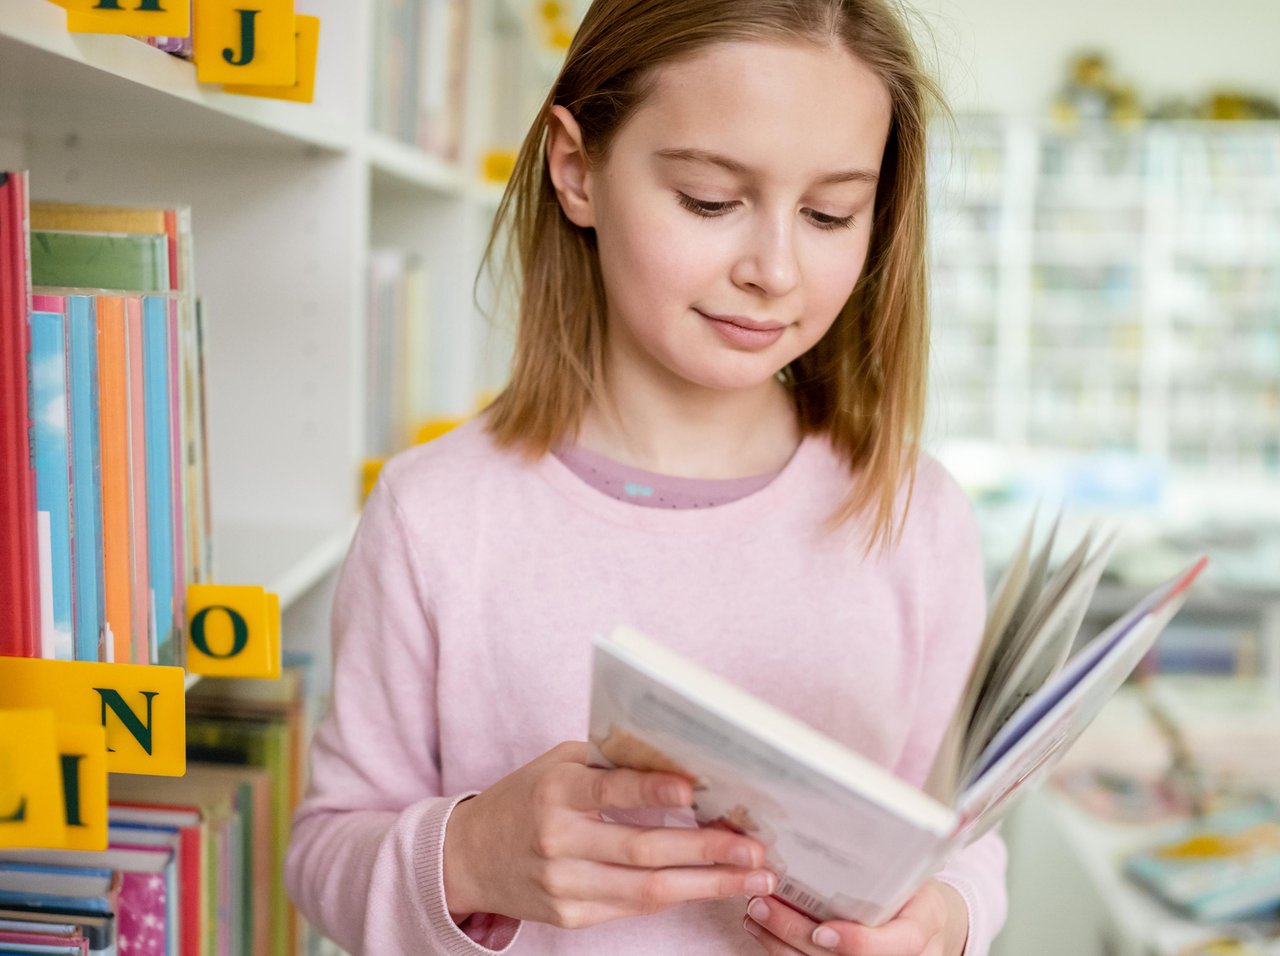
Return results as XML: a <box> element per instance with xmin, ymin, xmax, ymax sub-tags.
<box><xmin>589</xmin><ymin>628</ymin><xmax>956</xmax><ymax>925</ymax></box>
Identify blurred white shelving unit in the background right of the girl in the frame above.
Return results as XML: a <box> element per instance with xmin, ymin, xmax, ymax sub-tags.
<box><xmin>931</xmin><ymin>119</ymin><xmax>1280</xmax><ymax>472</ymax></box>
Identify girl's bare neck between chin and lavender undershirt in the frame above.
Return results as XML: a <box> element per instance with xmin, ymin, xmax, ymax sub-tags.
<box><xmin>577</xmin><ymin>371</ymin><xmax>801</xmax><ymax>479</ymax></box>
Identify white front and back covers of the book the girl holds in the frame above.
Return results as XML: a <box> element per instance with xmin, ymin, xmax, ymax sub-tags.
<box><xmin>589</xmin><ymin>559</ymin><xmax>1204</xmax><ymax>925</ymax></box>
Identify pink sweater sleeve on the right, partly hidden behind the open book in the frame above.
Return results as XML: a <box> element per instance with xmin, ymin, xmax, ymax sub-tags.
<box><xmin>897</xmin><ymin>462</ymin><xmax>1007</xmax><ymax>956</ymax></box>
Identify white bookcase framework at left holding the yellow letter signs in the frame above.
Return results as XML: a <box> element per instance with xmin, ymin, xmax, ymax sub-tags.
<box><xmin>0</xmin><ymin>0</ymin><xmax>570</xmax><ymax>659</ymax></box>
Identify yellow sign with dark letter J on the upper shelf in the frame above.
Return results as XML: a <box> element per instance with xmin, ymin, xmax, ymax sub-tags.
<box><xmin>192</xmin><ymin>0</ymin><xmax>297</xmax><ymax>86</ymax></box>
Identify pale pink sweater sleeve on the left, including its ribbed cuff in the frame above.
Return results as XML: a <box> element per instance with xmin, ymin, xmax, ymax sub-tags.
<box><xmin>285</xmin><ymin>479</ymin><xmax>520</xmax><ymax>956</ymax></box>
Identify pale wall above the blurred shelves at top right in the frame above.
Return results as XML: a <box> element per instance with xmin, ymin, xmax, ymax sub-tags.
<box><xmin>910</xmin><ymin>0</ymin><xmax>1280</xmax><ymax>116</ymax></box>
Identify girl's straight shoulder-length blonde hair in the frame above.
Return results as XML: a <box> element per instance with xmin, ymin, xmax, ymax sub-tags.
<box><xmin>484</xmin><ymin>0</ymin><xmax>942</xmax><ymax>550</ymax></box>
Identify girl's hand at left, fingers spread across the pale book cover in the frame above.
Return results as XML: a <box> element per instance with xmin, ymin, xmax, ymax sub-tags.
<box><xmin>444</xmin><ymin>741</ymin><xmax>777</xmax><ymax>928</ymax></box>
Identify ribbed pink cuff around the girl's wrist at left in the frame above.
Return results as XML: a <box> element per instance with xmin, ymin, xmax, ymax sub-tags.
<box><xmin>413</xmin><ymin>792</ymin><xmax>521</xmax><ymax>956</ymax></box>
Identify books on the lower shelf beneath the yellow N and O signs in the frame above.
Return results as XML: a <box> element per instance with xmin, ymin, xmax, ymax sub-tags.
<box><xmin>0</xmin><ymin>657</ymin><xmax>314</xmax><ymax>956</ymax></box>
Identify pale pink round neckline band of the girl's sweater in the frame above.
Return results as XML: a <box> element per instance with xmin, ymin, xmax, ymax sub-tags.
<box><xmin>534</xmin><ymin>434</ymin><xmax>824</xmax><ymax>534</ymax></box>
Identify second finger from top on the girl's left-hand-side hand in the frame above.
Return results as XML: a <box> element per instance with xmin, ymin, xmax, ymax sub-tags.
<box><xmin>573</xmin><ymin>820</ymin><xmax>764</xmax><ymax>870</ymax></box>
